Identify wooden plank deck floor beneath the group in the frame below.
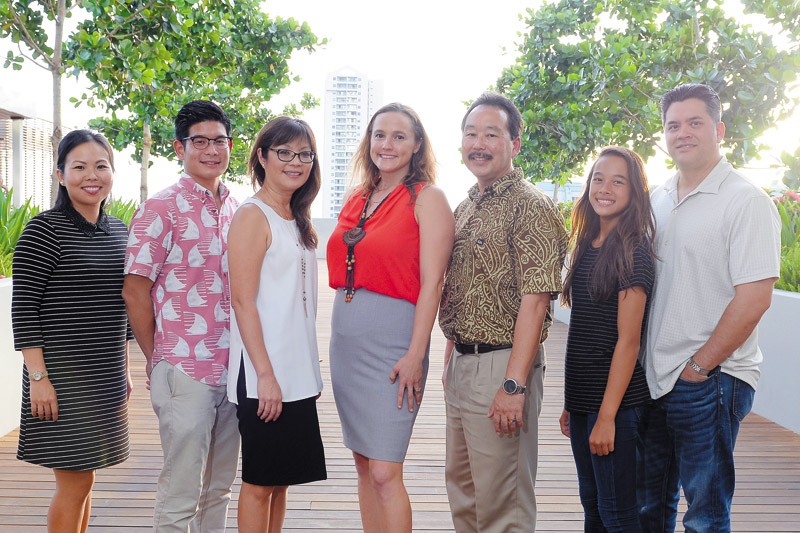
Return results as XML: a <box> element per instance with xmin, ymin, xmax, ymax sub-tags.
<box><xmin>0</xmin><ymin>263</ymin><xmax>800</xmax><ymax>533</ymax></box>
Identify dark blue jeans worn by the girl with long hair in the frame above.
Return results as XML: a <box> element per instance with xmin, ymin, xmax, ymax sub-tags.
<box><xmin>569</xmin><ymin>407</ymin><xmax>641</xmax><ymax>533</ymax></box>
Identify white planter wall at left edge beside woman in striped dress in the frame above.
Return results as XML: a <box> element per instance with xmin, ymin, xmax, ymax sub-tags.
<box><xmin>0</xmin><ymin>278</ymin><xmax>22</xmax><ymax>436</ymax></box>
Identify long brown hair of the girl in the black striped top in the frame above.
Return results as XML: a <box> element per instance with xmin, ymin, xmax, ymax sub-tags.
<box><xmin>561</xmin><ymin>146</ymin><xmax>655</xmax><ymax>305</ymax></box>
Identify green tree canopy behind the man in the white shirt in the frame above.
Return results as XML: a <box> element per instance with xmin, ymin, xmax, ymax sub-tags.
<box><xmin>497</xmin><ymin>0</ymin><xmax>800</xmax><ymax>183</ymax></box>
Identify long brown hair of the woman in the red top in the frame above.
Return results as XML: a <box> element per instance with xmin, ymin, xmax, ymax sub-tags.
<box><xmin>352</xmin><ymin>102</ymin><xmax>436</xmax><ymax>200</ymax></box>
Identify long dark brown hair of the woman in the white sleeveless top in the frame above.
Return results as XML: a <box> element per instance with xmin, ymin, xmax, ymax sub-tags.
<box><xmin>247</xmin><ymin>117</ymin><xmax>321</xmax><ymax>248</ymax></box>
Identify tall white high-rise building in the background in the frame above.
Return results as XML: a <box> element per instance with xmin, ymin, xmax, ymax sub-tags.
<box><xmin>322</xmin><ymin>67</ymin><xmax>383</xmax><ymax>218</ymax></box>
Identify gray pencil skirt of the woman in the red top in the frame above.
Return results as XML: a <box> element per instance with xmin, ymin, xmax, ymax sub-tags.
<box><xmin>330</xmin><ymin>289</ymin><xmax>430</xmax><ymax>463</ymax></box>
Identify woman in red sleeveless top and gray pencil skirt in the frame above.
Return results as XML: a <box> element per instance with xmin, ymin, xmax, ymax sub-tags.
<box><xmin>327</xmin><ymin>104</ymin><xmax>455</xmax><ymax>533</ymax></box>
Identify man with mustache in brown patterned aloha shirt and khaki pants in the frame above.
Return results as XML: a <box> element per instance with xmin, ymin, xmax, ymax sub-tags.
<box><xmin>439</xmin><ymin>93</ymin><xmax>567</xmax><ymax>533</ymax></box>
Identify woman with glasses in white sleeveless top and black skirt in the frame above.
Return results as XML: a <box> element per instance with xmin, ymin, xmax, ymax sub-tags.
<box><xmin>228</xmin><ymin>117</ymin><xmax>327</xmax><ymax>533</ymax></box>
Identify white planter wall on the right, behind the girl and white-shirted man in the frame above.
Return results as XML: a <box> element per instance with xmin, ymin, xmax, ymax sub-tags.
<box><xmin>554</xmin><ymin>290</ymin><xmax>800</xmax><ymax>434</ymax></box>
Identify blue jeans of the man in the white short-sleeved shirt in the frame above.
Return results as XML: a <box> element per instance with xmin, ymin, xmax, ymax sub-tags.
<box><xmin>638</xmin><ymin>369</ymin><xmax>755</xmax><ymax>533</ymax></box>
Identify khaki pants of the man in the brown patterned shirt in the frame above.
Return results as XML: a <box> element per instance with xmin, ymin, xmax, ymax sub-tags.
<box><xmin>445</xmin><ymin>345</ymin><xmax>545</xmax><ymax>533</ymax></box>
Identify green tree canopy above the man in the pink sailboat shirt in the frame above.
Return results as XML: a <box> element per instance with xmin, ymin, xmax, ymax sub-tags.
<box><xmin>67</xmin><ymin>0</ymin><xmax>324</xmax><ymax>199</ymax></box>
